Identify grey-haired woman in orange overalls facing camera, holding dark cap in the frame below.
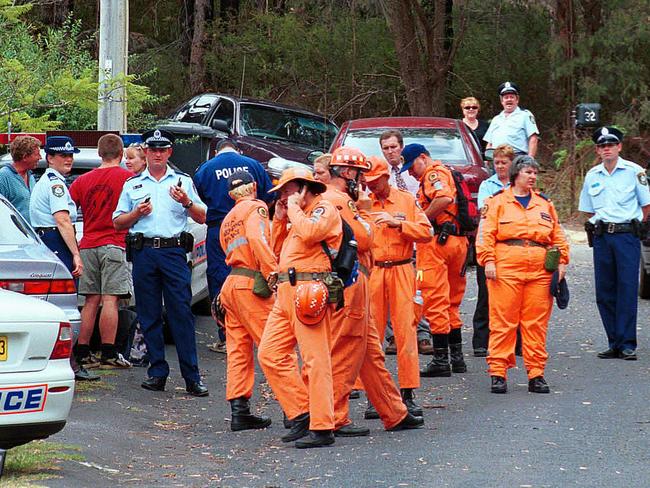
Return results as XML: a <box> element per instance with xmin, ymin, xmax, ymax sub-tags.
<box><xmin>476</xmin><ymin>156</ymin><xmax>569</xmax><ymax>393</ymax></box>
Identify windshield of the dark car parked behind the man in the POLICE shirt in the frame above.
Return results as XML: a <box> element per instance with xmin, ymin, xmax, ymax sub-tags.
<box><xmin>241</xmin><ymin>103</ymin><xmax>337</xmax><ymax>150</ymax></box>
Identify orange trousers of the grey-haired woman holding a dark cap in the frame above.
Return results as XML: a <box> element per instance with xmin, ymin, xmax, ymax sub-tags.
<box><xmin>487</xmin><ymin>243</ymin><xmax>553</xmax><ymax>379</ymax></box>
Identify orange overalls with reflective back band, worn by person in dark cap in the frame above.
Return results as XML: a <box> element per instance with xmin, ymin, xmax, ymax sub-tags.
<box><xmin>220</xmin><ymin>198</ymin><xmax>277</xmax><ymax>400</ymax></box>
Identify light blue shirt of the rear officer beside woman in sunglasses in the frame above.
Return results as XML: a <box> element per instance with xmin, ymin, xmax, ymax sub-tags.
<box><xmin>483</xmin><ymin>107</ymin><xmax>539</xmax><ymax>153</ymax></box>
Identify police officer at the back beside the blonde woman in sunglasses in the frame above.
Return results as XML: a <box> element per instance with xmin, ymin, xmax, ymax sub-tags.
<box><xmin>483</xmin><ymin>81</ymin><xmax>539</xmax><ymax>158</ymax></box>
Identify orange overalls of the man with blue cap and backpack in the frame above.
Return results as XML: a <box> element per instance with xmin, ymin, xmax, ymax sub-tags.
<box><xmin>416</xmin><ymin>161</ymin><xmax>469</xmax><ymax>334</ymax></box>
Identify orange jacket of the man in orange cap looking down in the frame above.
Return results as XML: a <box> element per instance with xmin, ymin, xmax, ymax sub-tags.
<box><xmin>370</xmin><ymin>187</ymin><xmax>433</xmax><ymax>261</ymax></box>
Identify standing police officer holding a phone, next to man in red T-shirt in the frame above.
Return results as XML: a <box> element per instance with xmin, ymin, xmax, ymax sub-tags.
<box><xmin>113</xmin><ymin>130</ymin><xmax>208</xmax><ymax>396</ymax></box>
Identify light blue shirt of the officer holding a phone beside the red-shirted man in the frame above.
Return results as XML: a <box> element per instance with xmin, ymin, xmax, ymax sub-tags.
<box><xmin>113</xmin><ymin>166</ymin><xmax>203</xmax><ymax>238</ymax></box>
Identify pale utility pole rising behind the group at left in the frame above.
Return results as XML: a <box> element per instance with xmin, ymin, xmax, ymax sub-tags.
<box><xmin>97</xmin><ymin>0</ymin><xmax>129</xmax><ymax>133</ymax></box>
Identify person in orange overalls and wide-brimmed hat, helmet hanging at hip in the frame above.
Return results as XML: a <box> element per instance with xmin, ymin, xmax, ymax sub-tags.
<box><xmin>257</xmin><ymin>168</ymin><xmax>342</xmax><ymax>448</ymax></box>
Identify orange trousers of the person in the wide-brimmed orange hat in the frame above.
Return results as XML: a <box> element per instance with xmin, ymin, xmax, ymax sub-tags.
<box><xmin>257</xmin><ymin>282</ymin><xmax>334</xmax><ymax>430</ymax></box>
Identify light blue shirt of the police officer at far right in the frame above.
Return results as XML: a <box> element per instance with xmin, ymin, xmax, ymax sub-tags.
<box><xmin>578</xmin><ymin>157</ymin><xmax>650</xmax><ymax>224</ymax></box>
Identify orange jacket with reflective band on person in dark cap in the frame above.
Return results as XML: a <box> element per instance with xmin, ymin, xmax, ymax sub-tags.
<box><xmin>219</xmin><ymin>198</ymin><xmax>278</xmax><ymax>277</ymax></box>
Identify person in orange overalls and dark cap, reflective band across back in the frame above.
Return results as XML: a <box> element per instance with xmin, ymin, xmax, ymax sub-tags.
<box><xmin>219</xmin><ymin>171</ymin><xmax>277</xmax><ymax>431</ymax></box>
